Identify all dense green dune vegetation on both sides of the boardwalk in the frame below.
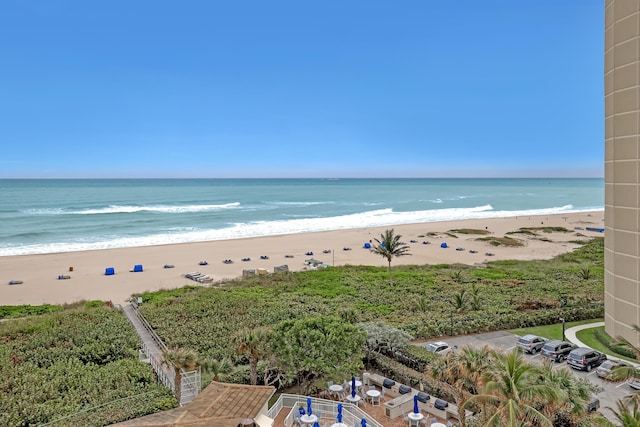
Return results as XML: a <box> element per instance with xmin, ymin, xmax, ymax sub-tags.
<box><xmin>0</xmin><ymin>239</ymin><xmax>604</xmax><ymax>426</ymax></box>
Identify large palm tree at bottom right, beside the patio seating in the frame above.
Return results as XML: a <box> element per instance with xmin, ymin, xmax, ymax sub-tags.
<box><xmin>460</xmin><ymin>348</ymin><xmax>564</xmax><ymax>427</ymax></box>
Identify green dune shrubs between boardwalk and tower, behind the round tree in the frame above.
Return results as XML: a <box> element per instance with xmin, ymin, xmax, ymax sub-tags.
<box><xmin>141</xmin><ymin>239</ymin><xmax>604</xmax><ymax>380</ymax></box>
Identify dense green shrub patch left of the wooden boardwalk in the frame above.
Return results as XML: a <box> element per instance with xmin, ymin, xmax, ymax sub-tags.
<box><xmin>0</xmin><ymin>302</ymin><xmax>177</xmax><ymax>427</ymax></box>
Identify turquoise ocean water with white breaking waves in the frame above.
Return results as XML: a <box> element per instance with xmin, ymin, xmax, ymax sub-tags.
<box><xmin>0</xmin><ymin>178</ymin><xmax>604</xmax><ymax>256</ymax></box>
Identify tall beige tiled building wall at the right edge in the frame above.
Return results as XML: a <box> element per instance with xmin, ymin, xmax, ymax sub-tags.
<box><xmin>604</xmin><ymin>0</ymin><xmax>640</xmax><ymax>345</ymax></box>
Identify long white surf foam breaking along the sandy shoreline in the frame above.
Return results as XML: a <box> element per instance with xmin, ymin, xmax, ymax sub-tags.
<box><xmin>0</xmin><ymin>205</ymin><xmax>598</xmax><ymax>256</ymax></box>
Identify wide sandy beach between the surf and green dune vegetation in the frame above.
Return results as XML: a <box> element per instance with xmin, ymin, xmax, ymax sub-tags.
<box><xmin>0</xmin><ymin>211</ymin><xmax>604</xmax><ymax>305</ymax></box>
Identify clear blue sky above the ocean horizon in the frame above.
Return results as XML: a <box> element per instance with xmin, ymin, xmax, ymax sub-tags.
<box><xmin>0</xmin><ymin>0</ymin><xmax>604</xmax><ymax>178</ymax></box>
